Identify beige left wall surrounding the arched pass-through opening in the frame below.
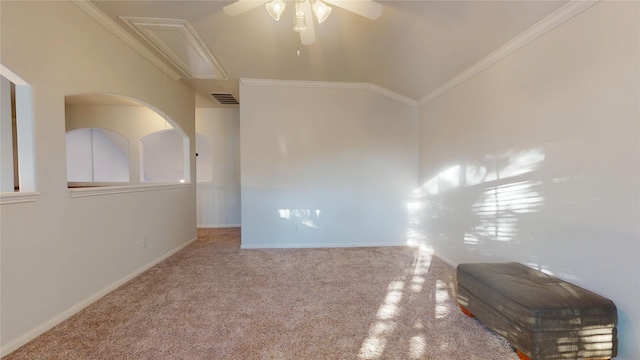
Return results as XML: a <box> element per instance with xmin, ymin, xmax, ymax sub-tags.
<box><xmin>0</xmin><ymin>1</ymin><xmax>196</xmax><ymax>354</ymax></box>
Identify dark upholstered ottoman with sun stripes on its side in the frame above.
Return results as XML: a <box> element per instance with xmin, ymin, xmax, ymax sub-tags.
<box><xmin>457</xmin><ymin>262</ymin><xmax>618</xmax><ymax>360</ymax></box>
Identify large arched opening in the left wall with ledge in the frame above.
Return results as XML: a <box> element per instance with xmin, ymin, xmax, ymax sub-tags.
<box><xmin>65</xmin><ymin>94</ymin><xmax>191</xmax><ymax>188</ymax></box>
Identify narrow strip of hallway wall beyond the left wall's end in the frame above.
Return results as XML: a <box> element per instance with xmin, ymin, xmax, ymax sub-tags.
<box><xmin>196</xmin><ymin>108</ymin><xmax>240</xmax><ymax>228</ymax></box>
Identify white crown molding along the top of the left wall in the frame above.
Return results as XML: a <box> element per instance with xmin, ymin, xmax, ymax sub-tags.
<box><xmin>69</xmin><ymin>0</ymin><xmax>182</xmax><ymax>80</ymax></box>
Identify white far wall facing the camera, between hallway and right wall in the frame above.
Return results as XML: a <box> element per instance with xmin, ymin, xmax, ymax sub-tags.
<box><xmin>240</xmin><ymin>80</ymin><xmax>417</xmax><ymax>248</ymax></box>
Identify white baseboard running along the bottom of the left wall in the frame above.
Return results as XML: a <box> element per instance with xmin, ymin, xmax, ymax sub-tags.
<box><xmin>0</xmin><ymin>237</ymin><xmax>198</xmax><ymax>357</ymax></box>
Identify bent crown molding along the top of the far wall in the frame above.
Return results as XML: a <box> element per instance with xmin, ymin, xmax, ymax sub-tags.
<box><xmin>240</xmin><ymin>78</ymin><xmax>418</xmax><ymax>107</ymax></box>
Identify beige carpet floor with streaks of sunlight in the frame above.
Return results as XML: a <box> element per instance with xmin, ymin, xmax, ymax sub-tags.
<box><xmin>4</xmin><ymin>229</ymin><xmax>518</xmax><ymax>360</ymax></box>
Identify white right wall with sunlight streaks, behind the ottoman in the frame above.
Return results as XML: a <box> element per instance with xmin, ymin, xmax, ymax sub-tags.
<box><xmin>419</xmin><ymin>1</ymin><xmax>640</xmax><ymax>360</ymax></box>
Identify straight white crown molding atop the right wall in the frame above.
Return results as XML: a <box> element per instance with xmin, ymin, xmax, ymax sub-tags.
<box><xmin>418</xmin><ymin>0</ymin><xmax>600</xmax><ymax>106</ymax></box>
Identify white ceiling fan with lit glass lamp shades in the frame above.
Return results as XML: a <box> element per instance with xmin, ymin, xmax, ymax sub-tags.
<box><xmin>222</xmin><ymin>0</ymin><xmax>382</xmax><ymax>45</ymax></box>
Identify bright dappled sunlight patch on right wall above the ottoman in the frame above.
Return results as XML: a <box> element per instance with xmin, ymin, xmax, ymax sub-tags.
<box><xmin>408</xmin><ymin>147</ymin><xmax>548</xmax><ymax>264</ymax></box>
